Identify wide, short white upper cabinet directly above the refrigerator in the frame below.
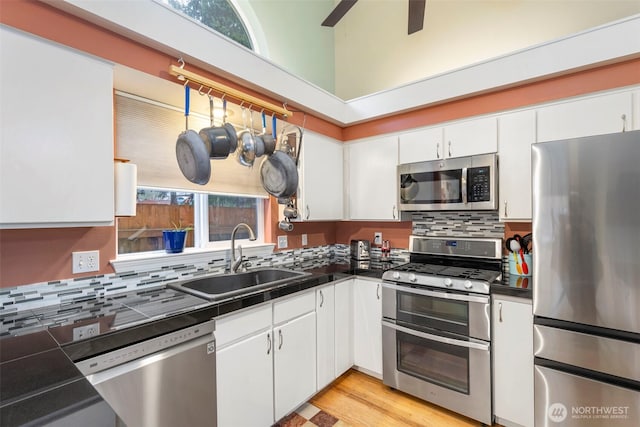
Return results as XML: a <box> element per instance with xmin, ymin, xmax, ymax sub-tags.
<box><xmin>538</xmin><ymin>92</ymin><xmax>634</xmax><ymax>142</ymax></box>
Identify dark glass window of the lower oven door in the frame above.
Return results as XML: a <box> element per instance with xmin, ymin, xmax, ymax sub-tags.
<box><xmin>396</xmin><ymin>331</ymin><xmax>469</xmax><ymax>394</ymax></box>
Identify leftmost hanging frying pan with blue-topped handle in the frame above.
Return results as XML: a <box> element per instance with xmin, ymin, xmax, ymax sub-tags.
<box><xmin>176</xmin><ymin>84</ymin><xmax>211</xmax><ymax>185</ymax></box>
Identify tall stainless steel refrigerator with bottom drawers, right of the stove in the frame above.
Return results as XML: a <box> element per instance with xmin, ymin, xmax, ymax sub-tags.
<box><xmin>532</xmin><ymin>131</ymin><xmax>640</xmax><ymax>427</ymax></box>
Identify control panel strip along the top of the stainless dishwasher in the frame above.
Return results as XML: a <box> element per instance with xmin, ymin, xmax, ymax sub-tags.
<box><xmin>76</xmin><ymin>320</ymin><xmax>216</xmax><ymax>376</ymax></box>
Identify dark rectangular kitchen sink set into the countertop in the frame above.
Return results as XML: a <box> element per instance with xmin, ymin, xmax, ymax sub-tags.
<box><xmin>167</xmin><ymin>268</ymin><xmax>310</xmax><ymax>301</ymax></box>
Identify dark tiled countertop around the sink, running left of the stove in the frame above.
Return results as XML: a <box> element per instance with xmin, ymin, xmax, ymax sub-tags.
<box><xmin>0</xmin><ymin>261</ymin><xmax>398</xmax><ymax>426</ymax></box>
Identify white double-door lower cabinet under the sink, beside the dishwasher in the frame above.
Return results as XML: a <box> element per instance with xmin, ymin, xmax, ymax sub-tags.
<box><xmin>216</xmin><ymin>289</ymin><xmax>317</xmax><ymax>427</ymax></box>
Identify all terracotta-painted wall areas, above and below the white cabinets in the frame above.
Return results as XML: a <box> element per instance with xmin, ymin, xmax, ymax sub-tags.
<box><xmin>0</xmin><ymin>0</ymin><xmax>640</xmax><ymax>287</ymax></box>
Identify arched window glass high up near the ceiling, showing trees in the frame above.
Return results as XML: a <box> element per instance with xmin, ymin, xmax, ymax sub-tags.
<box><xmin>163</xmin><ymin>0</ymin><xmax>253</xmax><ymax>50</ymax></box>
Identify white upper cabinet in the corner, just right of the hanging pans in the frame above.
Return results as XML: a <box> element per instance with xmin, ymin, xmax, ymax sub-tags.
<box><xmin>297</xmin><ymin>131</ymin><xmax>344</xmax><ymax>221</ymax></box>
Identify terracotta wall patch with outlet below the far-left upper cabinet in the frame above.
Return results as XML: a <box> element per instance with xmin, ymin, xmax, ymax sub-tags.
<box><xmin>0</xmin><ymin>227</ymin><xmax>116</xmax><ymax>288</ymax></box>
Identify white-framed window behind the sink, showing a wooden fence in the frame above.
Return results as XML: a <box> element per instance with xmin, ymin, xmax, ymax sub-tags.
<box><xmin>118</xmin><ymin>188</ymin><xmax>263</xmax><ymax>254</ymax></box>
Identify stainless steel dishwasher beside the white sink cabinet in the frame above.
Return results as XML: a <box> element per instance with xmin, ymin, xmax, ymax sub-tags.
<box><xmin>76</xmin><ymin>320</ymin><xmax>217</xmax><ymax>427</ymax></box>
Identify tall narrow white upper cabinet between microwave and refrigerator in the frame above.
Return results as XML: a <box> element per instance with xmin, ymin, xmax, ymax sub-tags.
<box><xmin>498</xmin><ymin>110</ymin><xmax>536</xmax><ymax>221</ymax></box>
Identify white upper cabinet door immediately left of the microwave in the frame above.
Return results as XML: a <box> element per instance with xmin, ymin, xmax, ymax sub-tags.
<box><xmin>346</xmin><ymin>136</ymin><xmax>399</xmax><ymax>221</ymax></box>
